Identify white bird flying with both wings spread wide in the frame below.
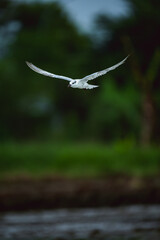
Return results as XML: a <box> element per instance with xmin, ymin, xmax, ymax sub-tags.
<box><xmin>26</xmin><ymin>56</ymin><xmax>129</xmax><ymax>89</ymax></box>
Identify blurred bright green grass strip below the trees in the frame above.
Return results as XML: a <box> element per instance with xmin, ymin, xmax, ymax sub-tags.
<box><xmin>0</xmin><ymin>142</ymin><xmax>160</xmax><ymax>178</ymax></box>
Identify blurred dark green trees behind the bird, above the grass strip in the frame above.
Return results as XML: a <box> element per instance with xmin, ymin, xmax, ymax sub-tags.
<box><xmin>0</xmin><ymin>0</ymin><xmax>160</xmax><ymax>142</ymax></box>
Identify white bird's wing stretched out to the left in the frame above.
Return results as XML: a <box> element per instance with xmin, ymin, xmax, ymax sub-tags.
<box><xmin>26</xmin><ymin>62</ymin><xmax>73</xmax><ymax>82</ymax></box>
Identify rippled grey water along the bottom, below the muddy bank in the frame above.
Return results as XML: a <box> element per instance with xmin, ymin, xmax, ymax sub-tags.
<box><xmin>0</xmin><ymin>205</ymin><xmax>160</xmax><ymax>240</ymax></box>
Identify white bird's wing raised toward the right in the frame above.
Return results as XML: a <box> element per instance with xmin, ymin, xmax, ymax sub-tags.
<box><xmin>81</xmin><ymin>55</ymin><xmax>129</xmax><ymax>82</ymax></box>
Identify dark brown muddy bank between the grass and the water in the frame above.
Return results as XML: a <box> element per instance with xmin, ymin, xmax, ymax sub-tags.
<box><xmin>0</xmin><ymin>176</ymin><xmax>160</xmax><ymax>211</ymax></box>
